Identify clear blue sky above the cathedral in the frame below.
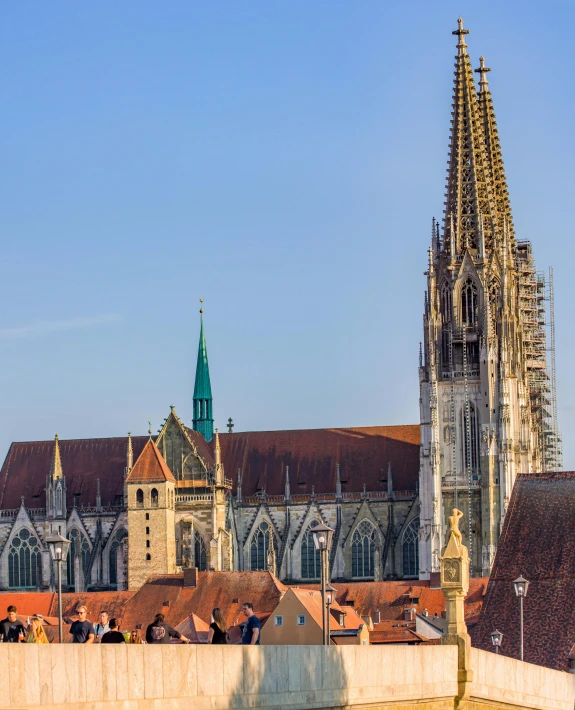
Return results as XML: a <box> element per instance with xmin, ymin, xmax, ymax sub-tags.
<box><xmin>0</xmin><ymin>0</ymin><xmax>575</xmax><ymax>469</ymax></box>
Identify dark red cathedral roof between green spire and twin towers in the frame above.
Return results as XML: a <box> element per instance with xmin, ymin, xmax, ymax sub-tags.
<box><xmin>212</xmin><ymin>425</ymin><xmax>420</xmax><ymax>496</ymax></box>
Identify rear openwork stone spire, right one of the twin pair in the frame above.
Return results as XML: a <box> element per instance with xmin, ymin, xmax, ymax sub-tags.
<box><xmin>475</xmin><ymin>57</ymin><xmax>515</xmax><ymax>246</ymax></box>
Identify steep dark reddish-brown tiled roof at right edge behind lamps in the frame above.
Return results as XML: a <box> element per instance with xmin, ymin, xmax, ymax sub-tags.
<box><xmin>472</xmin><ymin>471</ymin><xmax>575</xmax><ymax>671</ymax></box>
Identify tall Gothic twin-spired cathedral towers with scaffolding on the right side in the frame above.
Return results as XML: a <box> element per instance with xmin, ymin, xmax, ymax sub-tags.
<box><xmin>419</xmin><ymin>19</ymin><xmax>560</xmax><ymax>579</ymax></box>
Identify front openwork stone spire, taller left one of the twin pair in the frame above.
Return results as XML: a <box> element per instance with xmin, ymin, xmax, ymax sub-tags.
<box><xmin>443</xmin><ymin>18</ymin><xmax>495</xmax><ymax>255</ymax></box>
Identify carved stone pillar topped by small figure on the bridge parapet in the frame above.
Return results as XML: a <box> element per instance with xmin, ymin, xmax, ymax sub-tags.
<box><xmin>440</xmin><ymin>508</ymin><xmax>473</xmax><ymax>710</ymax></box>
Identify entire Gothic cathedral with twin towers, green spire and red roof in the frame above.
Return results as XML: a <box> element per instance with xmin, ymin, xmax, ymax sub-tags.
<box><xmin>0</xmin><ymin>21</ymin><xmax>557</xmax><ymax>591</ymax></box>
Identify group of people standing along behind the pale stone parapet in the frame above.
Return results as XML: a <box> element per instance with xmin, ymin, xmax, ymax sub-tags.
<box><xmin>0</xmin><ymin>602</ymin><xmax>260</xmax><ymax>646</ymax></box>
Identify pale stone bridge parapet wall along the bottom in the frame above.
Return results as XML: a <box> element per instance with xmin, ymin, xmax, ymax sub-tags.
<box><xmin>0</xmin><ymin>644</ymin><xmax>575</xmax><ymax>710</ymax></box>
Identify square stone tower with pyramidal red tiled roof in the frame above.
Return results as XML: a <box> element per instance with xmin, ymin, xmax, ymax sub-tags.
<box><xmin>125</xmin><ymin>438</ymin><xmax>176</xmax><ymax>589</ymax></box>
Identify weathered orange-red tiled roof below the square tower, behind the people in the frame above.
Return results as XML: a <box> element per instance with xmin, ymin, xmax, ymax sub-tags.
<box><xmin>122</xmin><ymin>572</ymin><xmax>287</xmax><ymax>629</ymax></box>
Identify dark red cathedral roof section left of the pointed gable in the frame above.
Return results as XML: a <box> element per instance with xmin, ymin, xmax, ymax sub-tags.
<box><xmin>0</xmin><ymin>436</ymin><xmax>148</xmax><ymax>509</ymax></box>
